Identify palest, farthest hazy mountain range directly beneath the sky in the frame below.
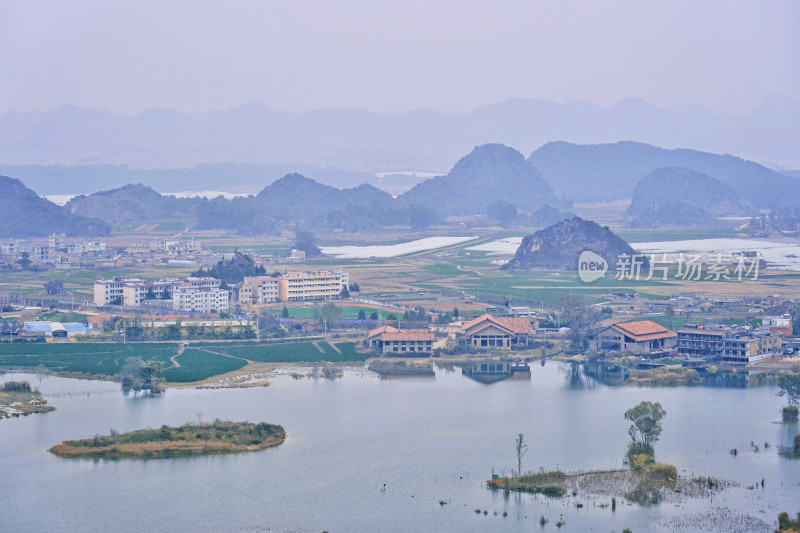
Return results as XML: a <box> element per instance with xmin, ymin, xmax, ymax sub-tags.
<box><xmin>0</xmin><ymin>95</ymin><xmax>800</xmax><ymax>194</ymax></box>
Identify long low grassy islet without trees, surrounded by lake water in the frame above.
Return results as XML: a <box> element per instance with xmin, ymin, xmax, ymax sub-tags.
<box><xmin>50</xmin><ymin>420</ymin><xmax>286</xmax><ymax>458</ymax></box>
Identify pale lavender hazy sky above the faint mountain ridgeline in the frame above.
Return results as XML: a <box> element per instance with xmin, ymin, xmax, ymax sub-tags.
<box><xmin>0</xmin><ymin>0</ymin><xmax>800</xmax><ymax>114</ymax></box>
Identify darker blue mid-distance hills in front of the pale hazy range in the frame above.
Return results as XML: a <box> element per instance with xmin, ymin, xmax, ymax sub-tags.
<box><xmin>4</xmin><ymin>137</ymin><xmax>800</xmax><ymax>235</ymax></box>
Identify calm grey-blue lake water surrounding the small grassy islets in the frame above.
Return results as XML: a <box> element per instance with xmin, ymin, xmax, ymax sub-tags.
<box><xmin>0</xmin><ymin>363</ymin><xmax>800</xmax><ymax>532</ymax></box>
